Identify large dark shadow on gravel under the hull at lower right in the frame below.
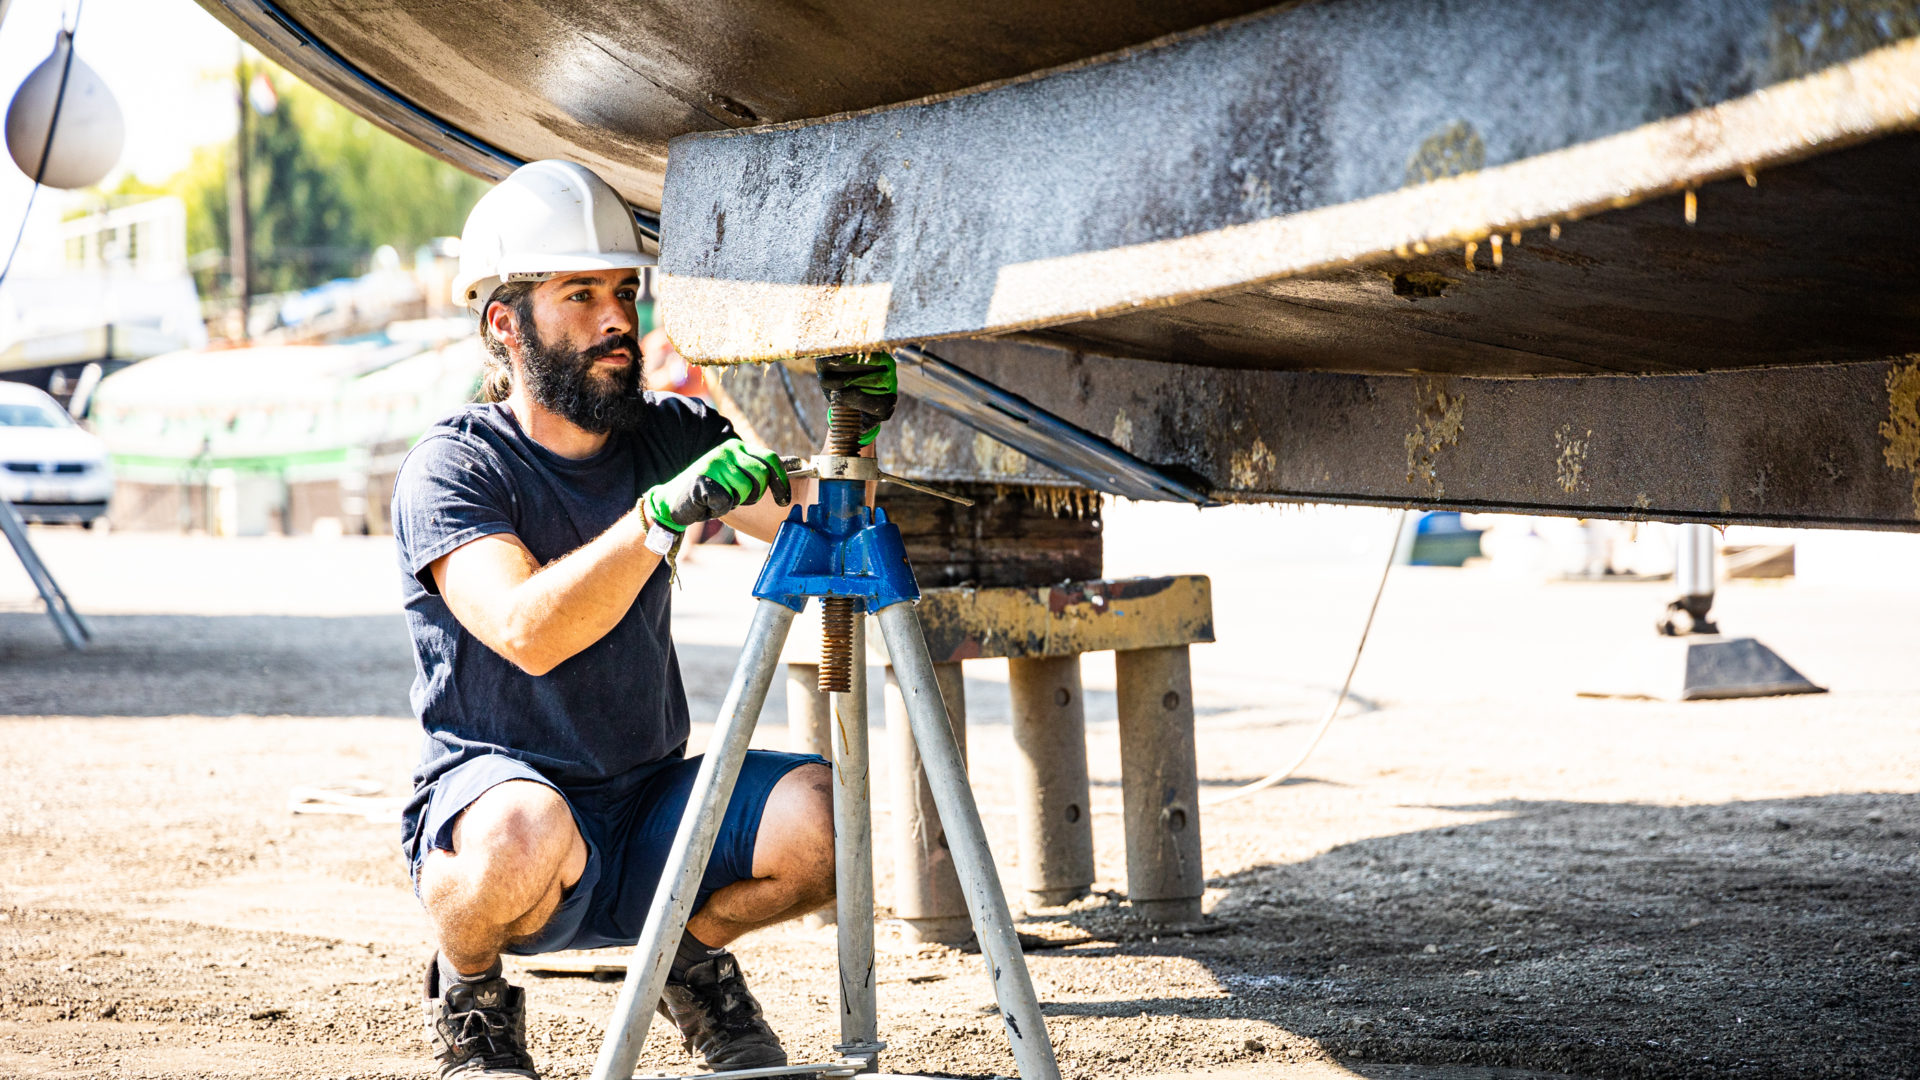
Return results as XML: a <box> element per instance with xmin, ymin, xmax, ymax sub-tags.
<box><xmin>1050</xmin><ymin>794</ymin><xmax>1920</xmax><ymax>1076</ymax></box>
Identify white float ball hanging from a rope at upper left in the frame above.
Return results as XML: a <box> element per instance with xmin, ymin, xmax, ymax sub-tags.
<box><xmin>6</xmin><ymin>33</ymin><xmax>127</xmax><ymax>188</ymax></box>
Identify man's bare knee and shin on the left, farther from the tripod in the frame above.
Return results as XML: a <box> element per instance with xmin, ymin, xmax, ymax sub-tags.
<box><xmin>420</xmin><ymin>780</ymin><xmax>588</xmax><ymax>974</ymax></box>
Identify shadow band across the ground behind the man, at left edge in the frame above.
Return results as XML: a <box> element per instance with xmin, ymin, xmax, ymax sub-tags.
<box><xmin>0</xmin><ymin>613</ymin><xmax>413</xmax><ymax>717</ymax></box>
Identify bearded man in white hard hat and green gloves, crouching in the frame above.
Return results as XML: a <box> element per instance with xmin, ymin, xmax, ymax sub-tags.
<box><xmin>394</xmin><ymin>161</ymin><xmax>895</xmax><ymax>1080</ymax></box>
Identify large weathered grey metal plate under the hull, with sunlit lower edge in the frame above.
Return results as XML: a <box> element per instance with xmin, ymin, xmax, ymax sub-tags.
<box><xmin>662</xmin><ymin>0</ymin><xmax>1920</xmax><ymax>375</ymax></box>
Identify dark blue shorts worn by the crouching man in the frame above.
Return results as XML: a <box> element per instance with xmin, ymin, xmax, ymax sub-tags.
<box><xmin>411</xmin><ymin>749</ymin><xmax>826</xmax><ymax>955</ymax></box>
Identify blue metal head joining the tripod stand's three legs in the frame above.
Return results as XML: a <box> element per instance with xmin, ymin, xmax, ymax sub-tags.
<box><xmin>753</xmin><ymin>480</ymin><xmax>920</xmax><ymax>613</ymax></box>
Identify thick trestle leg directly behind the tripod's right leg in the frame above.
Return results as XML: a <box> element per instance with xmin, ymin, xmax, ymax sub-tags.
<box><xmin>887</xmin><ymin>663</ymin><xmax>973</xmax><ymax>945</ymax></box>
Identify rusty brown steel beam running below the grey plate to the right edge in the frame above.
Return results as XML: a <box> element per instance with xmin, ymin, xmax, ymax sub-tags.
<box><xmin>867</xmin><ymin>340</ymin><xmax>1920</xmax><ymax>530</ymax></box>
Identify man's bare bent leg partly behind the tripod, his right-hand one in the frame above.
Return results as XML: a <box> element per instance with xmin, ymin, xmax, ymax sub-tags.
<box><xmin>687</xmin><ymin>765</ymin><xmax>833</xmax><ymax>949</ymax></box>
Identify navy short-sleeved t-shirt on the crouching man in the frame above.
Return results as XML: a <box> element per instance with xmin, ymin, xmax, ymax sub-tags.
<box><xmin>394</xmin><ymin>392</ymin><xmax>733</xmax><ymax>810</ymax></box>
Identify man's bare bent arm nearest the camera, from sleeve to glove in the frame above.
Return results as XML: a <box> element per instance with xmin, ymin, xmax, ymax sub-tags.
<box><xmin>432</xmin><ymin>511</ymin><xmax>660</xmax><ymax>675</ymax></box>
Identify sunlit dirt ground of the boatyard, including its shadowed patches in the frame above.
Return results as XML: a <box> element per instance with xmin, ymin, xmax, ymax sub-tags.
<box><xmin>0</xmin><ymin>511</ymin><xmax>1920</xmax><ymax>1080</ymax></box>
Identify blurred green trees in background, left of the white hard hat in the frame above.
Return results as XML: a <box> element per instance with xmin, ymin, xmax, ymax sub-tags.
<box><xmin>167</xmin><ymin>60</ymin><xmax>488</xmax><ymax>296</ymax></box>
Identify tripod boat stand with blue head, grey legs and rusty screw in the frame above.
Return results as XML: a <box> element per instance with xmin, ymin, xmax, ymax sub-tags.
<box><xmin>593</xmin><ymin>413</ymin><xmax>1060</xmax><ymax>1080</ymax></box>
